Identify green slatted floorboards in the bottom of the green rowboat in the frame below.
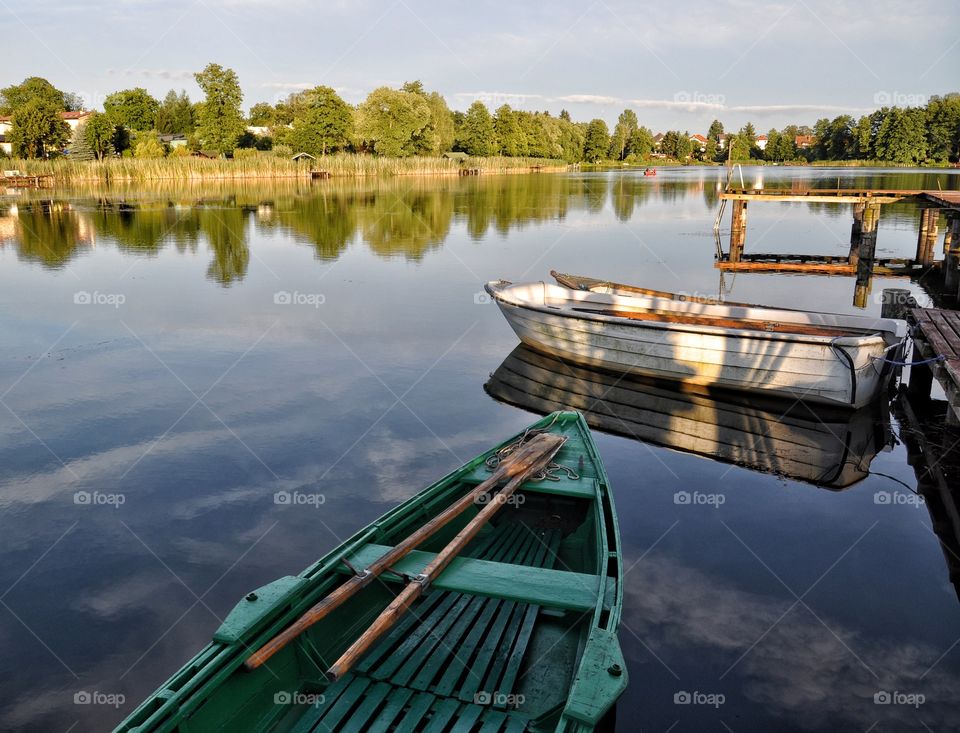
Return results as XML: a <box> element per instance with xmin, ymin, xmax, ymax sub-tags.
<box><xmin>292</xmin><ymin>522</ymin><xmax>560</xmax><ymax>733</ymax></box>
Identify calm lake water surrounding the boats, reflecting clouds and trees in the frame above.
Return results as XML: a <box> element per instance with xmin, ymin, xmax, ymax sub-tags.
<box><xmin>0</xmin><ymin>168</ymin><xmax>960</xmax><ymax>733</ymax></box>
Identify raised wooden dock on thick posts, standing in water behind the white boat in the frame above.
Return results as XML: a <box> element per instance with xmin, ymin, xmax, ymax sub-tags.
<box><xmin>714</xmin><ymin>185</ymin><xmax>960</xmax><ymax>308</ymax></box>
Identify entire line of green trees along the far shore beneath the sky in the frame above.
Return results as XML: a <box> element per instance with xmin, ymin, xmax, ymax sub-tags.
<box><xmin>0</xmin><ymin>64</ymin><xmax>960</xmax><ymax>163</ymax></box>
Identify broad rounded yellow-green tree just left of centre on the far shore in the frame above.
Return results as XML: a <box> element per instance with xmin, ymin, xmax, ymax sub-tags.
<box><xmin>356</xmin><ymin>87</ymin><xmax>430</xmax><ymax>157</ymax></box>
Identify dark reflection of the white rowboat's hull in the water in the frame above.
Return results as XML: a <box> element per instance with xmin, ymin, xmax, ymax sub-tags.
<box><xmin>484</xmin><ymin>345</ymin><xmax>891</xmax><ymax>489</ymax></box>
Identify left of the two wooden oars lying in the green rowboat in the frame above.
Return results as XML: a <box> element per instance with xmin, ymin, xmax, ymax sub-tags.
<box><xmin>244</xmin><ymin>435</ymin><xmax>563</xmax><ymax>670</ymax></box>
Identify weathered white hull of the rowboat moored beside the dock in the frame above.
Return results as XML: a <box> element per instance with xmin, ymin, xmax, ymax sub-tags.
<box><xmin>487</xmin><ymin>281</ymin><xmax>905</xmax><ymax>407</ymax></box>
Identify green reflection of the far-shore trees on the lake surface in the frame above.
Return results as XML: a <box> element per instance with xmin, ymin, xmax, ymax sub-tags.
<box><xmin>0</xmin><ymin>168</ymin><xmax>960</xmax><ymax>286</ymax></box>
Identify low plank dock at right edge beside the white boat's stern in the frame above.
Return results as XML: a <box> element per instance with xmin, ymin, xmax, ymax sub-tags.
<box><xmin>908</xmin><ymin>308</ymin><xmax>960</xmax><ymax>425</ymax></box>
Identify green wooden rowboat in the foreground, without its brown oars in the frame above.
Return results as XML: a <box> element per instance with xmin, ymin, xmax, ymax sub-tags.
<box><xmin>116</xmin><ymin>412</ymin><xmax>627</xmax><ymax>733</ymax></box>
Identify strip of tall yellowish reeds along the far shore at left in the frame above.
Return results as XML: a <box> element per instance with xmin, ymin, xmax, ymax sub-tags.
<box><xmin>0</xmin><ymin>155</ymin><xmax>567</xmax><ymax>185</ymax></box>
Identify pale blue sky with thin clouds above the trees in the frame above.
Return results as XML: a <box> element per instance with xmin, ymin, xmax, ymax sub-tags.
<box><xmin>0</xmin><ymin>0</ymin><xmax>960</xmax><ymax>133</ymax></box>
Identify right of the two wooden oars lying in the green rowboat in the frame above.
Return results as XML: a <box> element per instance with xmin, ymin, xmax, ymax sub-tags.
<box><xmin>326</xmin><ymin>435</ymin><xmax>566</xmax><ymax>682</ymax></box>
